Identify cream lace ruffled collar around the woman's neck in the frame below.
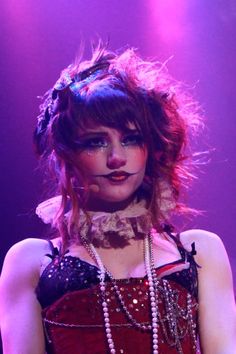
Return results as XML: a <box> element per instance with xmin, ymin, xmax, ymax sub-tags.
<box><xmin>36</xmin><ymin>181</ymin><xmax>176</xmax><ymax>247</ymax></box>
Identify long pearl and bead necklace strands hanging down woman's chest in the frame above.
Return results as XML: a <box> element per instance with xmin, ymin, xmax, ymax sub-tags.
<box><xmin>82</xmin><ymin>235</ymin><xmax>159</xmax><ymax>354</ymax></box>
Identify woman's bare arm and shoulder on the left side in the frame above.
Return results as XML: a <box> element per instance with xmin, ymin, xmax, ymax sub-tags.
<box><xmin>0</xmin><ymin>239</ymin><xmax>46</xmax><ymax>354</ymax></box>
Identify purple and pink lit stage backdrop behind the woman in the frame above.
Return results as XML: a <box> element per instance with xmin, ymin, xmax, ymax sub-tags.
<box><xmin>0</xmin><ymin>0</ymin><xmax>236</xmax><ymax>286</ymax></box>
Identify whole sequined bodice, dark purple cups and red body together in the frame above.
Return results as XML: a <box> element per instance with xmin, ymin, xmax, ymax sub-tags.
<box><xmin>36</xmin><ymin>234</ymin><xmax>198</xmax><ymax>354</ymax></box>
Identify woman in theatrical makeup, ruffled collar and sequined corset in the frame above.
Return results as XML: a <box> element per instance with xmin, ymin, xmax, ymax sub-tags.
<box><xmin>1</xmin><ymin>48</ymin><xmax>236</xmax><ymax>354</ymax></box>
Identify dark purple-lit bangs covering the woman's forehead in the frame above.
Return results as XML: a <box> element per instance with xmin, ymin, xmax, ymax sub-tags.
<box><xmin>74</xmin><ymin>84</ymin><xmax>142</xmax><ymax>132</ymax></box>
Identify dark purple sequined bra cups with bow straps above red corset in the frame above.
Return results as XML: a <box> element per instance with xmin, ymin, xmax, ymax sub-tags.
<box><xmin>36</xmin><ymin>240</ymin><xmax>197</xmax><ymax>308</ymax></box>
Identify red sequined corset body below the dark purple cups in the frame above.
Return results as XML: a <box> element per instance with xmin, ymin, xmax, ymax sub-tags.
<box><xmin>43</xmin><ymin>278</ymin><xmax>198</xmax><ymax>354</ymax></box>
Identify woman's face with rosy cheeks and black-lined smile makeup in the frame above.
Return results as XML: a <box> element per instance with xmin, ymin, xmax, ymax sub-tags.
<box><xmin>76</xmin><ymin>124</ymin><xmax>147</xmax><ymax>211</ymax></box>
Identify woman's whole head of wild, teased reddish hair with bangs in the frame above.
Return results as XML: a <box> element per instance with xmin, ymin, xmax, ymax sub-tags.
<box><xmin>34</xmin><ymin>46</ymin><xmax>202</xmax><ymax>249</ymax></box>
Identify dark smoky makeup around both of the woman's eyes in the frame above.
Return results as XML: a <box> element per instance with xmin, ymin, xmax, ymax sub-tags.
<box><xmin>76</xmin><ymin>131</ymin><xmax>144</xmax><ymax>150</ymax></box>
